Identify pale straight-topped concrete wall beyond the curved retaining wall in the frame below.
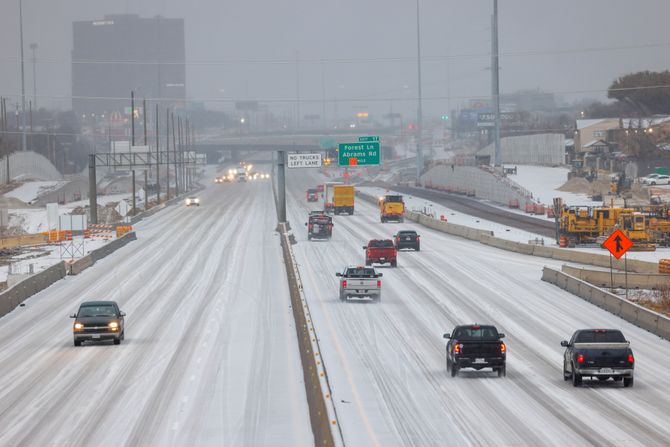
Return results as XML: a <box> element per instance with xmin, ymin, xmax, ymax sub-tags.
<box><xmin>477</xmin><ymin>134</ymin><xmax>565</xmax><ymax>166</ymax></box>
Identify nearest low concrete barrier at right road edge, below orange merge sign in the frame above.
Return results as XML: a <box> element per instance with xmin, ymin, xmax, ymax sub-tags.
<box><xmin>542</xmin><ymin>267</ymin><xmax>670</xmax><ymax>340</ymax></box>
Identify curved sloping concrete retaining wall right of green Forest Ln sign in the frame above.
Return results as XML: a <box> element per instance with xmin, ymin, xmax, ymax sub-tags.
<box><xmin>421</xmin><ymin>165</ymin><xmax>535</xmax><ymax>208</ymax></box>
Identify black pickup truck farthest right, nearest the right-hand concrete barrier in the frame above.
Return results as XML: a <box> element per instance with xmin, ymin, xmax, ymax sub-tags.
<box><xmin>561</xmin><ymin>329</ymin><xmax>635</xmax><ymax>388</ymax></box>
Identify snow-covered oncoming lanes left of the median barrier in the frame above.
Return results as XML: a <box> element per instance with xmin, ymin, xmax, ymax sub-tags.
<box><xmin>0</xmin><ymin>182</ymin><xmax>313</xmax><ymax>446</ymax></box>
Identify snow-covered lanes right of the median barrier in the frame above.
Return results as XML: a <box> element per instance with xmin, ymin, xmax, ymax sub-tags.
<box><xmin>287</xmin><ymin>170</ymin><xmax>670</xmax><ymax>446</ymax></box>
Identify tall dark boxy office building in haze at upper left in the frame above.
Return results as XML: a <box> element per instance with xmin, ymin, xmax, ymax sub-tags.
<box><xmin>72</xmin><ymin>14</ymin><xmax>186</xmax><ymax>114</ymax></box>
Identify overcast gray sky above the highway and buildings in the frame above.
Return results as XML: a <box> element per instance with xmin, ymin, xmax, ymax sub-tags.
<box><xmin>0</xmin><ymin>0</ymin><xmax>670</xmax><ymax>121</ymax></box>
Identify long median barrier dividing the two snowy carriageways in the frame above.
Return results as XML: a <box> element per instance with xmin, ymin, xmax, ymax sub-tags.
<box><xmin>278</xmin><ymin>223</ymin><xmax>344</xmax><ymax>446</ymax></box>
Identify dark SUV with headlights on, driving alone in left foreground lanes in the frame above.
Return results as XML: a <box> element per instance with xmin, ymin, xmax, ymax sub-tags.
<box><xmin>70</xmin><ymin>301</ymin><xmax>126</xmax><ymax>346</ymax></box>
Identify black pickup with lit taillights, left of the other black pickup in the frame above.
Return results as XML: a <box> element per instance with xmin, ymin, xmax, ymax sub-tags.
<box><xmin>444</xmin><ymin>324</ymin><xmax>507</xmax><ymax>377</ymax></box>
